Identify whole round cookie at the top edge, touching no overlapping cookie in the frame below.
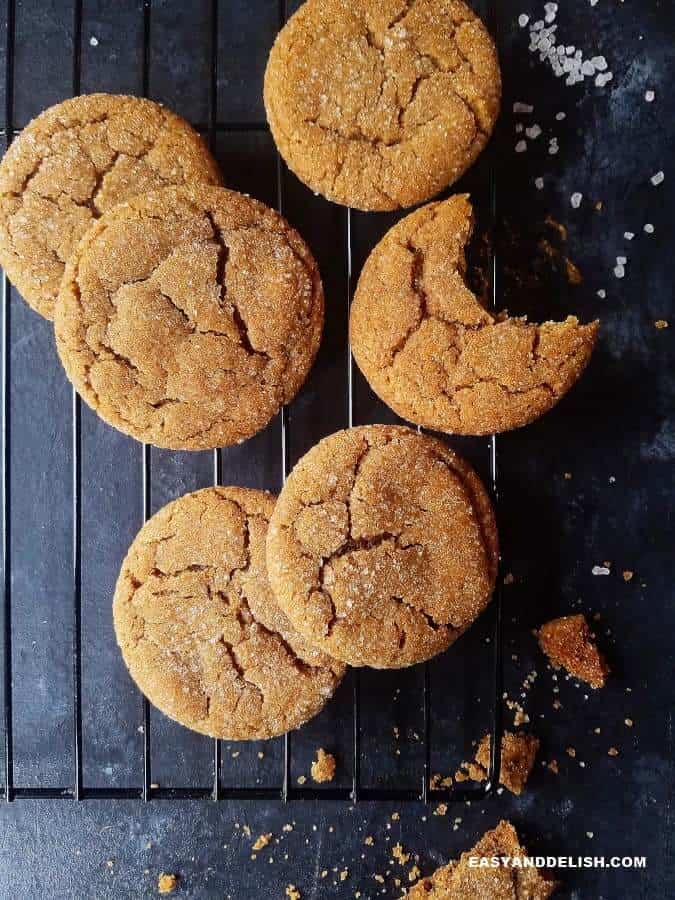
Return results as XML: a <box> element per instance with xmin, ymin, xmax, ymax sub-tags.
<box><xmin>264</xmin><ymin>0</ymin><xmax>501</xmax><ymax>210</ymax></box>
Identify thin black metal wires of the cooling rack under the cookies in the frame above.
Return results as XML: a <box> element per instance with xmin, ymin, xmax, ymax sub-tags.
<box><xmin>0</xmin><ymin>0</ymin><xmax>502</xmax><ymax>803</ymax></box>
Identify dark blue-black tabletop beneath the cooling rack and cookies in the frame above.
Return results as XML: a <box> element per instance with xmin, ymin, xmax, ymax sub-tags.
<box><xmin>0</xmin><ymin>0</ymin><xmax>675</xmax><ymax>900</ymax></box>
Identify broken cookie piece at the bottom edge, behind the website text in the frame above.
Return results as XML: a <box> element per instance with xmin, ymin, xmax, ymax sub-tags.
<box><xmin>406</xmin><ymin>822</ymin><xmax>558</xmax><ymax>900</ymax></box>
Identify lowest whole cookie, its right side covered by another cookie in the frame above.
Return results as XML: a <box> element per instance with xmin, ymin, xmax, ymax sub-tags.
<box><xmin>113</xmin><ymin>487</ymin><xmax>344</xmax><ymax>740</ymax></box>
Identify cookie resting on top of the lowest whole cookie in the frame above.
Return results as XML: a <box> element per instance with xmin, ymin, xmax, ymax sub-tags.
<box><xmin>267</xmin><ymin>425</ymin><xmax>498</xmax><ymax>668</ymax></box>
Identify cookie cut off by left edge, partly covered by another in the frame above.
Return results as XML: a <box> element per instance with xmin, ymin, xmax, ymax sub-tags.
<box><xmin>0</xmin><ymin>94</ymin><xmax>221</xmax><ymax>319</ymax></box>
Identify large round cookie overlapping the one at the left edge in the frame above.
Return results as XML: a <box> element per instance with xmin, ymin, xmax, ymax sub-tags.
<box><xmin>55</xmin><ymin>185</ymin><xmax>323</xmax><ymax>450</ymax></box>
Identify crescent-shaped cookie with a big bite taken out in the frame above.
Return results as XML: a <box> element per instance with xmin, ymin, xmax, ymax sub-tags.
<box><xmin>349</xmin><ymin>194</ymin><xmax>598</xmax><ymax>435</ymax></box>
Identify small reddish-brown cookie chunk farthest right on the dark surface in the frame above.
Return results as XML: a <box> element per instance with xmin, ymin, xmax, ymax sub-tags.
<box><xmin>537</xmin><ymin>613</ymin><xmax>610</xmax><ymax>688</ymax></box>
